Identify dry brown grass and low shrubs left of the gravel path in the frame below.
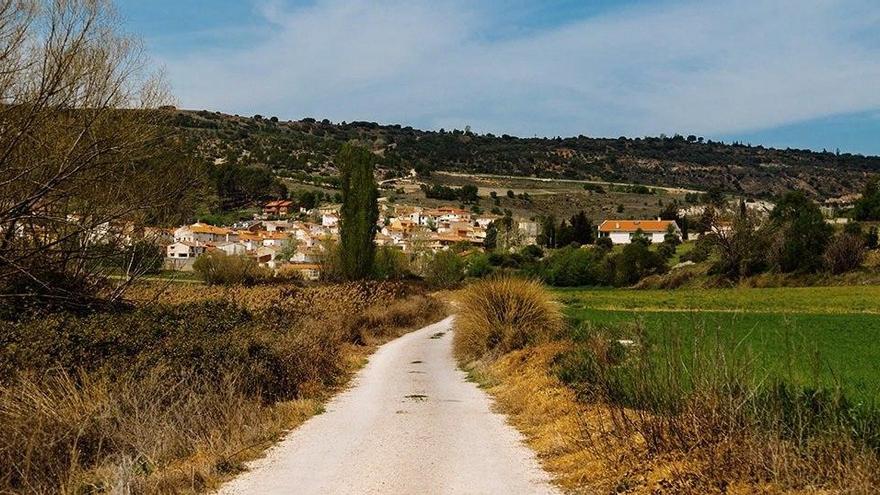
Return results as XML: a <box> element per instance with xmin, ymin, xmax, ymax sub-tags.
<box><xmin>0</xmin><ymin>284</ymin><xmax>445</xmax><ymax>493</ymax></box>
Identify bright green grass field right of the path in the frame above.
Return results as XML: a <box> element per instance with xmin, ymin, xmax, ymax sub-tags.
<box><xmin>557</xmin><ymin>286</ymin><xmax>880</xmax><ymax>402</ymax></box>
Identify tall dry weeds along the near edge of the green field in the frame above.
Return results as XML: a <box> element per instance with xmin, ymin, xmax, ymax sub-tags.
<box><xmin>554</xmin><ymin>324</ymin><xmax>880</xmax><ymax>493</ymax></box>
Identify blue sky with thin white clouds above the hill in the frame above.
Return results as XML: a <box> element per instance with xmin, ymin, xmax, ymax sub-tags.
<box><xmin>117</xmin><ymin>0</ymin><xmax>880</xmax><ymax>155</ymax></box>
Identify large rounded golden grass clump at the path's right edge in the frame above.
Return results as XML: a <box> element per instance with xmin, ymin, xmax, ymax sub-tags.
<box><xmin>453</xmin><ymin>277</ymin><xmax>563</xmax><ymax>361</ymax></box>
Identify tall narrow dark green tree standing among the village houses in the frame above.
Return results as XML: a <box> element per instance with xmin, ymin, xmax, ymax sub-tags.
<box><xmin>336</xmin><ymin>144</ymin><xmax>379</xmax><ymax>280</ymax></box>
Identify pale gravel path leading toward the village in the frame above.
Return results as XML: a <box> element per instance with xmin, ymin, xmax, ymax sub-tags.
<box><xmin>219</xmin><ymin>318</ymin><xmax>558</xmax><ymax>495</ymax></box>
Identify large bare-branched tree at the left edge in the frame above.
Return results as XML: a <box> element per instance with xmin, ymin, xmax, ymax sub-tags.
<box><xmin>0</xmin><ymin>0</ymin><xmax>197</xmax><ymax>312</ymax></box>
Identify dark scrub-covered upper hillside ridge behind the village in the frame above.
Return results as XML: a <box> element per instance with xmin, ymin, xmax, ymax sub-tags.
<box><xmin>174</xmin><ymin>110</ymin><xmax>880</xmax><ymax>198</ymax></box>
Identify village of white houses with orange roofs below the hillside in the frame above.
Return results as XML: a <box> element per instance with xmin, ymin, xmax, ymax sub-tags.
<box><xmin>154</xmin><ymin>202</ymin><xmax>681</xmax><ymax>280</ymax></box>
